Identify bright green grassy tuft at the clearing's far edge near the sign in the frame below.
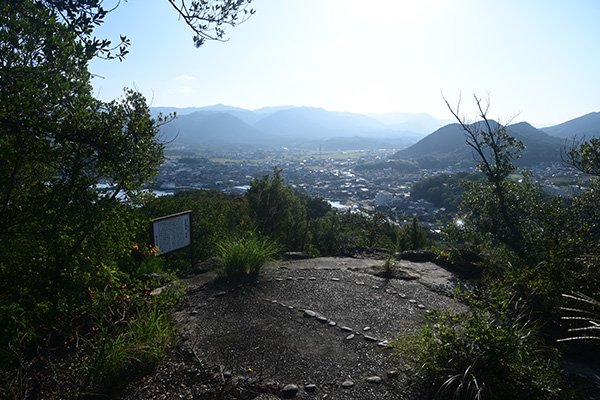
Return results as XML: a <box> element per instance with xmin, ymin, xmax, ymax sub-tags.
<box><xmin>218</xmin><ymin>235</ymin><xmax>278</xmax><ymax>277</ymax></box>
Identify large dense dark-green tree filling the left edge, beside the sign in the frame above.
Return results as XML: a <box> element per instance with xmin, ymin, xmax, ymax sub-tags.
<box><xmin>0</xmin><ymin>1</ymin><xmax>169</xmax><ymax>344</ymax></box>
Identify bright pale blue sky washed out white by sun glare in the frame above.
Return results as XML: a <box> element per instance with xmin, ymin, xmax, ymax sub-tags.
<box><xmin>90</xmin><ymin>0</ymin><xmax>600</xmax><ymax>127</ymax></box>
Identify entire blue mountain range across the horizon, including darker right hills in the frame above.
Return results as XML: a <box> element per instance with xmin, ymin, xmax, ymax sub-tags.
<box><xmin>151</xmin><ymin>104</ymin><xmax>600</xmax><ymax>167</ymax></box>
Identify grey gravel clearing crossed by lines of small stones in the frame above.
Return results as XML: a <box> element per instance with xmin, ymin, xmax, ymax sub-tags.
<box><xmin>113</xmin><ymin>258</ymin><xmax>463</xmax><ymax>400</ymax></box>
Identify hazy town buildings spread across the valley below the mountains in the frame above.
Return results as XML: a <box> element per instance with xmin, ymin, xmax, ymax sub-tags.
<box><xmin>153</xmin><ymin>151</ymin><xmax>583</xmax><ymax>231</ymax></box>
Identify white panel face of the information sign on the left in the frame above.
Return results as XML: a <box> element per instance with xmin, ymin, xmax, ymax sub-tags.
<box><xmin>152</xmin><ymin>213</ymin><xmax>192</xmax><ymax>254</ymax></box>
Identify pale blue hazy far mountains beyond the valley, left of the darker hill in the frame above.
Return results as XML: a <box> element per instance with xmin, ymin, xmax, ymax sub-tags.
<box><xmin>151</xmin><ymin>104</ymin><xmax>442</xmax><ymax>150</ymax></box>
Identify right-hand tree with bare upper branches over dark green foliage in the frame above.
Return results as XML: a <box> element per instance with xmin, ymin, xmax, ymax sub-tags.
<box><xmin>446</xmin><ymin>94</ymin><xmax>600</xmax><ymax>325</ymax></box>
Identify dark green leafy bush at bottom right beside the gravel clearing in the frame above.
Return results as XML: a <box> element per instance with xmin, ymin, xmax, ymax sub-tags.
<box><xmin>392</xmin><ymin>309</ymin><xmax>569</xmax><ymax>400</ymax></box>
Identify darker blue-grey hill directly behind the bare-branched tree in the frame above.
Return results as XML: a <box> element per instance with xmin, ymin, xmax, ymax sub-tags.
<box><xmin>392</xmin><ymin>121</ymin><xmax>563</xmax><ymax>168</ymax></box>
